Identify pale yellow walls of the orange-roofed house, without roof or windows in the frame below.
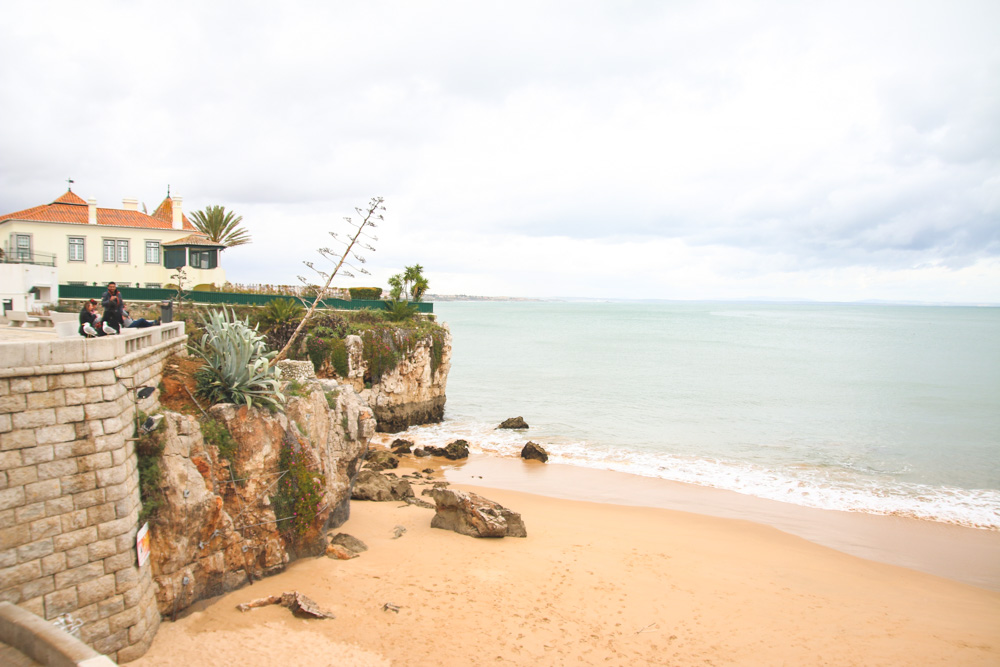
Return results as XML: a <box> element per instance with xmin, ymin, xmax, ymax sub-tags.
<box><xmin>0</xmin><ymin>221</ymin><xmax>226</xmax><ymax>287</ymax></box>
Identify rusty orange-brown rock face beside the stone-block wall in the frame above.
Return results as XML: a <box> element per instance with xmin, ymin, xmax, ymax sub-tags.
<box><xmin>150</xmin><ymin>380</ymin><xmax>375</xmax><ymax>615</ymax></box>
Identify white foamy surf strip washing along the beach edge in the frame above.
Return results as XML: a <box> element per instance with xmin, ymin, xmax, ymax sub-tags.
<box><xmin>383</xmin><ymin>420</ymin><xmax>1000</xmax><ymax>530</ymax></box>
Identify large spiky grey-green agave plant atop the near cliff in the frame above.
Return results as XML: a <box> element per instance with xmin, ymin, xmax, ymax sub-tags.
<box><xmin>188</xmin><ymin>308</ymin><xmax>285</xmax><ymax>410</ymax></box>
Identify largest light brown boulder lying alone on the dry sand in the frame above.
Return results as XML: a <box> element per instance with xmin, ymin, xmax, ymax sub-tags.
<box><xmin>423</xmin><ymin>488</ymin><xmax>528</xmax><ymax>537</ymax></box>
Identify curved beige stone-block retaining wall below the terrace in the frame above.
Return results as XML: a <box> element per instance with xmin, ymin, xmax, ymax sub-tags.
<box><xmin>0</xmin><ymin>322</ymin><xmax>185</xmax><ymax>662</ymax></box>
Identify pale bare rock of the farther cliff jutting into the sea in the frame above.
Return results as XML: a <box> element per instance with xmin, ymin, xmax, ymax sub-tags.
<box><xmin>346</xmin><ymin>328</ymin><xmax>451</xmax><ymax>433</ymax></box>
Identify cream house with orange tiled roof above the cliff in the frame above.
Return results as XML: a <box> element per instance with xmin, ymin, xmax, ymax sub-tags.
<box><xmin>0</xmin><ymin>190</ymin><xmax>226</xmax><ymax>287</ymax></box>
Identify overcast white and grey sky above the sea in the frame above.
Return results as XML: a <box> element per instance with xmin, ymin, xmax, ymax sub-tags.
<box><xmin>0</xmin><ymin>0</ymin><xmax>1000</xmax><ymax>303</ymax></box>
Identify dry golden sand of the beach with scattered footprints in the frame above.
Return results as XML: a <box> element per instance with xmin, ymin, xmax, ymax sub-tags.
<box><xmin>132</xmin><ymin>462</ymin><xmax>1000</xmax><ymax>666</ymax></box>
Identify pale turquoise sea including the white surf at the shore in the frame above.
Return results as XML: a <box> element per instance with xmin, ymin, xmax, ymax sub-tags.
<box><xmin>392</xmin><ymin>302</ymin><xmax>1000</xmax><ymax>529</ymax></box>
